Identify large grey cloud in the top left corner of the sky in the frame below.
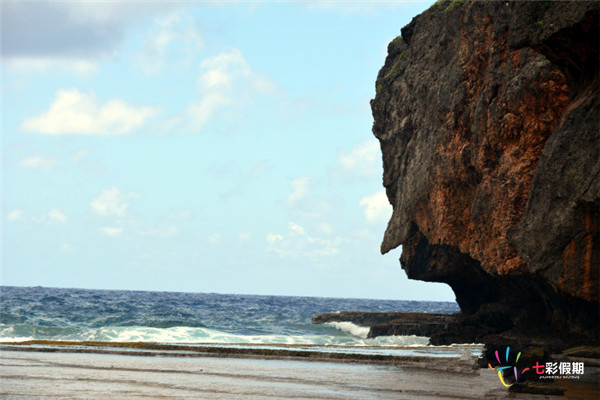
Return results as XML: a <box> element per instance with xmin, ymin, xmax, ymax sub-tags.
<box><xmin>2</xmin><ymin>1</ymin><xmax>173</xmax><ymax>61</ymax></box>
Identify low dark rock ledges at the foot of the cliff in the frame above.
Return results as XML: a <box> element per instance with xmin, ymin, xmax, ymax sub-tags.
<box><xmin>311</xmin><ymin>311</ymin><xmax>600</xmax><ymax>399</ymax></box>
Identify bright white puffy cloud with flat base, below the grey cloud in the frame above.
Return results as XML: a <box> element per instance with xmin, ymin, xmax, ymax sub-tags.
<box><xmin>21</xmin><ymin>89</ymin><xmax>159</xmax><ymax>135</ymax></box>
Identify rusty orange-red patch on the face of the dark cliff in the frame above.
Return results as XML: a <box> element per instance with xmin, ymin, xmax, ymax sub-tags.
<box><xmin>415</xmin><ymin>13</ymin><xmax>568</xmax><ymax>276</ymax></box>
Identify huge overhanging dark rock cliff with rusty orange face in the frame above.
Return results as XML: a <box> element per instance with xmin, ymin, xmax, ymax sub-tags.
<box><xmin>371</xmin><ymin>1</ymin><xmax>600</xmax><ymax>344</ymax></box>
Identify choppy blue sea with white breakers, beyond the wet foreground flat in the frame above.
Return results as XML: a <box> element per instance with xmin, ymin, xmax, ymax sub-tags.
<box><xmin>0</xmin><ymin>286</ymin><xmax>459</xmax><ymax>347</ymax></box>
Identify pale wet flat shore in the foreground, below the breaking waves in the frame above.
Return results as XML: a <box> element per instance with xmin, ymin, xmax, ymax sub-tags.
<box><xmin>0</xmin><ymin>346</ymin><xmax>572</xmax><ymax>400</ymax></box>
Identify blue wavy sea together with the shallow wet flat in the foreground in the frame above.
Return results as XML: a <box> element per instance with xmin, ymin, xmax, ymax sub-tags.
<box><xmin>0</xmin><ymin>286</ymin><xmax>506</xmax><ymax>400</ymax></box>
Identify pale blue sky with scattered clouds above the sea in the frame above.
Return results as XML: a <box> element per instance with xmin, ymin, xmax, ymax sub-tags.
<box><xmin>1</xmin><ymin>0</ymin><xmax>454</xmax><ymax>301</ymax></box>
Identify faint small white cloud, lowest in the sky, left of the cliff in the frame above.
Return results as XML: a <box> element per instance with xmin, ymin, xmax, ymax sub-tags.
<box><xmin>266</xmin><ymin>222</ymin><xmax>343</xmax><ymax>259</ymax></box>
